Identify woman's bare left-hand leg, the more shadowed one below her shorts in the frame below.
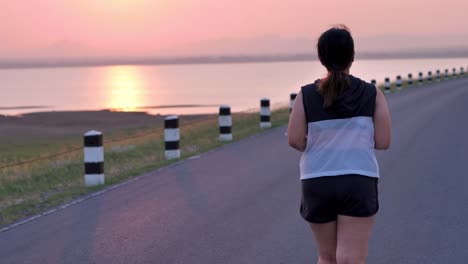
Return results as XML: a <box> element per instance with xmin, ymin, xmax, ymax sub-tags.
<box><xmin>310</xmin><ymin>221</ymin><xmax>337</xmax><ymax>264</ymax></box>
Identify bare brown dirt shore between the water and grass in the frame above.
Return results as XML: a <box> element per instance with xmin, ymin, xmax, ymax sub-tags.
<box><xmin>0</xmin><ymin>110</ymin><xmax>212</xmax><ymax>144</ymax></box>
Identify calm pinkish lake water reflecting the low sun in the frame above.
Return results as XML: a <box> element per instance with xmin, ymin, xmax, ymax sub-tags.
<box><xmin>0</xmin><ymin>58</ymin><xmax>468</xmax><ymax>115</ymax></box>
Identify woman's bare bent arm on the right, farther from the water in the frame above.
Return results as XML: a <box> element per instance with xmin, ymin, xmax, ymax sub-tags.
<box><xmin>374</xmin><ymin>88</ymin><xmax>392</xmax><ymax>150</ymax></box>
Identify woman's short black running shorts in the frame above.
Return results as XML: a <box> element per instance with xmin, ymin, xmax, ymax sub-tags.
<box><xmin>300</xmin><ymin>174</ymin><xmax>379</xmax><ymax>224</ymax></box>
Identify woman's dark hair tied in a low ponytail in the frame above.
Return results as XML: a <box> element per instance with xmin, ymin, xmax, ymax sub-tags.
<box><xmin>317</xmin><ymin>25</ymin><xmax>354</xmax><ymax>108</ymax></box>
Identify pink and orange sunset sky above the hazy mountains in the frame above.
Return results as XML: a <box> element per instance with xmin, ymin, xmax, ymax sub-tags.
<box><xmin>0</xmin><ymin>0</ymin><xmax>468</xmax><ymax>56</ymax></box>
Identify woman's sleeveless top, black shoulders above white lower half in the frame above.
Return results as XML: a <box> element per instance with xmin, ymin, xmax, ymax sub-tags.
<box><xmin>300</xmin><ymin>75</ymin><xmax>379</xmax><ymax>179</ymax></box>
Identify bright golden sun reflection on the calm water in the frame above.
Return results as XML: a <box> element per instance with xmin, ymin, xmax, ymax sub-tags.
<box><xmin>106</xmin><ymin>66</ymin><xmax>146</xmax><ymax>112</ymax></box>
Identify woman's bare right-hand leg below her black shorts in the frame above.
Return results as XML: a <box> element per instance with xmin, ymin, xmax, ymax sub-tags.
<box><xmin>336</xmin><ymin>215</ymin><xmax>374</xmax><ymax>264</ymax></box>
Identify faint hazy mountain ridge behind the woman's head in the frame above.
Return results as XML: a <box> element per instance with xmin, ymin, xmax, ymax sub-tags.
<box><xmin>167</xmin><ymin>35</ymin><xmax>468</xmax><ymax>55</ymax></box>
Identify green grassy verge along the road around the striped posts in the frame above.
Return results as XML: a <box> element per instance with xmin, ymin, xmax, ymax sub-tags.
<box><xmin>0</xmin><ymin>108</ymin><xmax>289</xmax><ymax>226</ymax></box>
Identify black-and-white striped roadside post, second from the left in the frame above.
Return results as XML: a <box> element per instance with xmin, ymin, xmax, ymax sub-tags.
<box><xmin>164</xmin><ymin>116</ymin><xmax>180</xmax><ymax>160</ymax></box>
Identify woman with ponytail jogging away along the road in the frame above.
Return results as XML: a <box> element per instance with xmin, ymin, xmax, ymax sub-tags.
<box><xmin>287</xmin><ymin>26</ymin><xmax>391</xmax><ymax>264</ymax></box>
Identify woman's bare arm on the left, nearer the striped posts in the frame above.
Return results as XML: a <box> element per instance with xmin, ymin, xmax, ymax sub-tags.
<box><xmin>288</xmin><ymin>91</ymin><xmax>307</xmax><ymax>152</ymax></box>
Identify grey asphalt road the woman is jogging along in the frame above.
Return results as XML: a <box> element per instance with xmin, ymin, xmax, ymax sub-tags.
<box><xmin>0</xmin><ymin>78</ymin><xmax>468</xmax><ymax>264</ymax></box>
